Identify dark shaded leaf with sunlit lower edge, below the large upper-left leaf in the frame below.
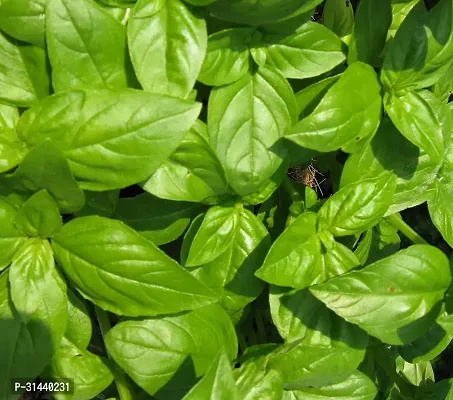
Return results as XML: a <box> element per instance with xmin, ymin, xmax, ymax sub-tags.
<box><xmin>114</xmin><ymin>193</ymin><xmax>198</xmax><ymax>245</ymax></box>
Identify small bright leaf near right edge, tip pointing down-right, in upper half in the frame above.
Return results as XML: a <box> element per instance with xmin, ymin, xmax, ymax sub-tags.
<box><xmin>384</xmin><ymin>90</ymin><xmax>445</xmax><ymax>162</ymax></box>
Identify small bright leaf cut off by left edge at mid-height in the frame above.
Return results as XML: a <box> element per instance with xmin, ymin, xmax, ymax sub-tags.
<box><xmin>0</xmin><ymin>197</ymin><xmax>27</xmax><ymax>271</ymax></box>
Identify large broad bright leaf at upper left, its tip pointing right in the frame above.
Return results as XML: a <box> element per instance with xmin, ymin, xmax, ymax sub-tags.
<box><xmin>18</xmin><ymin>89</ymin><xmax>200</xmax><ymax>191</ymax></box>
